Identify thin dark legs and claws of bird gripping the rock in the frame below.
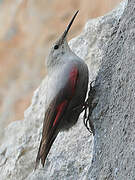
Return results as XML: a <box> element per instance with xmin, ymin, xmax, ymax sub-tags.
<box><xmin>82</xmin><ymin>81</ymin><xmax>96</xmax><ymax>135</ymax></box>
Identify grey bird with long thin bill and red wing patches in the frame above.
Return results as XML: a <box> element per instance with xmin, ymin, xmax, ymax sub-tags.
<box><xmin>35</xmin><ymin>10</ymin><xmax>89</xmax><ymax>169</ymax></box>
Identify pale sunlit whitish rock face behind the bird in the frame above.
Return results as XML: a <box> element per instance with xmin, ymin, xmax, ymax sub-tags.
<box><xmin>0</xmin><ymin>1</ymin><xmax>128</xmax><ymax>180</ymax></box>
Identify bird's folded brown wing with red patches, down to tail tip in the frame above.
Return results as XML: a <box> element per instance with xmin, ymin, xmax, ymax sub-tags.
<box><xmin>36</xmin><ymin>66</ymin><xmax>79</xmax><ymax>167</ymax></box>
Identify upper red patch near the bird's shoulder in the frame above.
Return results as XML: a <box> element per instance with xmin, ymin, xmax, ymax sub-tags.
<box><xmin>69</xmin><ymin>67</ymin><xmax>78</xmax><ymax>95</ymax></box>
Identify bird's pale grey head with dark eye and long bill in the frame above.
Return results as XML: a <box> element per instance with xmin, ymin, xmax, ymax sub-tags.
<box><xmin>46</xmin><ymin>11</ymin><xmax>79</xmax><ymax>69</ymax></box>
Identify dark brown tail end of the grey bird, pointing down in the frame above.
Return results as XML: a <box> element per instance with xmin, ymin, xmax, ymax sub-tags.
<box><xmin>35</xmin><ymin>133</ymin><xmax>57</xmax><ymax>170</ymax></box>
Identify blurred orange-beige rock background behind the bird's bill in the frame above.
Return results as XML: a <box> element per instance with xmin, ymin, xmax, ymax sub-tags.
<box><xmin>0</xmin><ymin>0</ymin><xmax>120</xmax><ymax>133</ymax></box>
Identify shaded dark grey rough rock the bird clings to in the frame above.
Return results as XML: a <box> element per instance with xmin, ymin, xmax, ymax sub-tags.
<box><xmin>87</xmin><ymin>0</ymin><xmax>135</xmax><ymax>180</ymax></box>
